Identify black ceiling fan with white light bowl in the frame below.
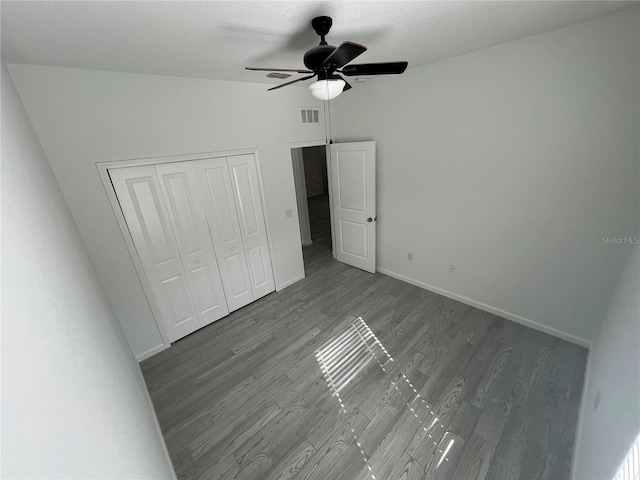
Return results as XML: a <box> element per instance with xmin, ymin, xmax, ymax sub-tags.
<box><xmin>246</xmin><ymin>17</ymin><xmax>408</xmax><ymax>100</ymax></box>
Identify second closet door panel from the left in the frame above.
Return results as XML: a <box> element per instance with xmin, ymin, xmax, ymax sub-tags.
<box><xmin>156</xmin><ymin>162</ymin><xmax>229</xmax><ymax>326</ymax></box>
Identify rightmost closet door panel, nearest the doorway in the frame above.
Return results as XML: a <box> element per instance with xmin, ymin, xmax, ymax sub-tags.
<box><xmin>228</xmin><ymin>155</ymin><xmax>275</xmax><ymax>298</ymax></box>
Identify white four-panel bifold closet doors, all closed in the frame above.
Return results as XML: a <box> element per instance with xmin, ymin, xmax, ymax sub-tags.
<box><xmin>108</xmin><ymin>154</ymin><xmax>275</xmax><ymax>342</ymax></box>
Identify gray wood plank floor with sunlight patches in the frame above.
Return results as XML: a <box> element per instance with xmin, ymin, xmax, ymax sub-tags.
<box><xmin>141</xmin><ymin>197</ymin><xmax>587</xmax><ymax>480</ymax></box>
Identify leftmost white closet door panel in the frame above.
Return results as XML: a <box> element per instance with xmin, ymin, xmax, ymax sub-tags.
<box><xmin>109</xmin><ymin>165</ymin><xmax>200</xmax><ymax>342</ymax></box>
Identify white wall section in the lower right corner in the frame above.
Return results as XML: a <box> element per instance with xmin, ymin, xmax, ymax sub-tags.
<box><xmin>573</xmin><ymin>246</ymin><xmax>640</xmax><ymax>480</ymax></box>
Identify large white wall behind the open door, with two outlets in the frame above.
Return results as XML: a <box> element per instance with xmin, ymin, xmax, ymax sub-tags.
<box><xmin>332</xmin><ymin>9</ymin><xmax>640</xmax><ymax>345</ymax></box>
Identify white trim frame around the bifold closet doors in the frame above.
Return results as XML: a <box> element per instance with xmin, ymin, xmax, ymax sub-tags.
<box><xmin>96</xmin><ymin>148</ymin><xmax>279</xmax><ymax>348</ymax></box>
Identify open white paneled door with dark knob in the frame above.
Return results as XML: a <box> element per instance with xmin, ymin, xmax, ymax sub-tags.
<box><xmin>331</xmin><ymin>142</ymin><xmax>376</xmax><ymax>273</ymax></box>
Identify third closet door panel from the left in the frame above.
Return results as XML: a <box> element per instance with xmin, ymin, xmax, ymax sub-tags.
<box><xmin>194</xmin><ymin>158</ymin><xmax>255</xmax><ymax>311</ymax></box>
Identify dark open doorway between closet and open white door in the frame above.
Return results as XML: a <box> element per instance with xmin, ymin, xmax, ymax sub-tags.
<box><xmin>291</xmin><ymin>145</ymin><xmax>332</xmax><ymax>270</ymax></box>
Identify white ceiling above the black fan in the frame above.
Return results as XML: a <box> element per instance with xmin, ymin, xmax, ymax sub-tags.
<box><xmin>1</xmin><ymin>1</ymin><xmax>640</xmax><ymax>83</ymax></box>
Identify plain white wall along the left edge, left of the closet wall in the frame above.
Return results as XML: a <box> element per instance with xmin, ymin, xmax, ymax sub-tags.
<box><xmin>0</xmin><ymin>65</ymin><xmax>175</xmax><ymax>479</ymax></box>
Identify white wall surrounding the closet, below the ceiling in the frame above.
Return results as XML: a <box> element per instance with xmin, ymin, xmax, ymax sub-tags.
<box><xmin>9</xmin><ymin>65</ymin><xmax>324</xmax><ymax>359</ymax></box>
